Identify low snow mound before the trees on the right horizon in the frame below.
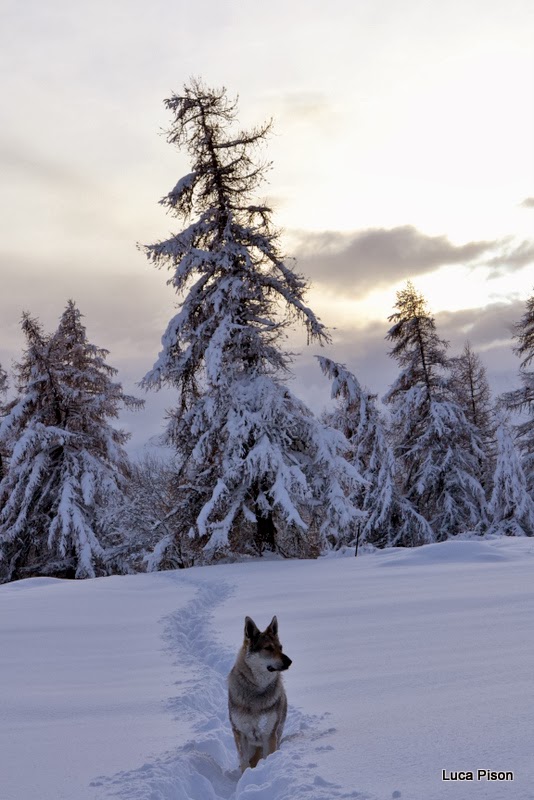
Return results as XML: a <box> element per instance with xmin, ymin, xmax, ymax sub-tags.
<box><xmin>381</xmin><ymin>540</ymin><xmax>514</xmax><ymax>567</ymax></box>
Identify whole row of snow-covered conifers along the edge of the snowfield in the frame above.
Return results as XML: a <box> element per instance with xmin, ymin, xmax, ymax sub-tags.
<box><xmin>0</xmin><ymin>81</ymin><xmax>534</xmax><ymax>581</ymax></box>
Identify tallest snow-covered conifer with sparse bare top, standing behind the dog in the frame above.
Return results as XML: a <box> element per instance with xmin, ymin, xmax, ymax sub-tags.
<box><xmin>143</xmin><ymin>81</ymin><xmax>362</xmax><ymax>566</ymax></box>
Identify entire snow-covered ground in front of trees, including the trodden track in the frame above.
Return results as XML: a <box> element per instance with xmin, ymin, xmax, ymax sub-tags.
<box><xmin>0</xmin><ymin>539</ymin><xmax>534</xmax><ymax>800</ymax></box>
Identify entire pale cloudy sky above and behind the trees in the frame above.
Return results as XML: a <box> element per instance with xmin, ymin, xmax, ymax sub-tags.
<box><xmin>0</xmin><ymin>0</ymin><xmax>534</xmax><ymax>452</ymax></box>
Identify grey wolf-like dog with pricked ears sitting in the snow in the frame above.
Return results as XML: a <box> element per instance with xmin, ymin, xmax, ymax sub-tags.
<box><xmin>228</xmin><ymin>617</ymin><xmax>291</xmax><ymax>772</ymax></box>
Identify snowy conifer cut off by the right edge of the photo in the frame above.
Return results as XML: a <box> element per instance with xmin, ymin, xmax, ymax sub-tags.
<box><xmin>503</xmin><ymin>294</ymin><xmax>534</xmax><ymax>499</ymax></box>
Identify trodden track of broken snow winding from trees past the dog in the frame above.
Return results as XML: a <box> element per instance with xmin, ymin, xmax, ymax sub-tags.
<box><xmin>91</xmin><ymin>576</ymin><xmax>372</xmax><ymax>800</ymax></box>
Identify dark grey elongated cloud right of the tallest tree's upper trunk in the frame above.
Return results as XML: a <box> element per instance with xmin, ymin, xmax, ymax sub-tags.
<box><xmin>296</xmin><ymin>225</ymin><xmax>499</xmax><ymax>294</ymax></box>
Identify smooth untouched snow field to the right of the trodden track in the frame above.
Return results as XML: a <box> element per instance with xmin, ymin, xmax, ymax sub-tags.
<box><xmin>211</xmin><ymin>538</ymin><xmax>534</xmax><ymax>800</ymax></box>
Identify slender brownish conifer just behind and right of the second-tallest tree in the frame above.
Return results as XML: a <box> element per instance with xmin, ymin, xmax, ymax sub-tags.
<box><xmin>449</xmin><ymin>342</ymin><xmax>495</xmax><ymax>492</ymax></box>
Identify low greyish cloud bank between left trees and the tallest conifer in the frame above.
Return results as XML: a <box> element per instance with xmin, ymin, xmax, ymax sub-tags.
<box><xmin>0</xmin><ymin>253</ymin><xmax>180</xmax><ymax>453</ymax></box>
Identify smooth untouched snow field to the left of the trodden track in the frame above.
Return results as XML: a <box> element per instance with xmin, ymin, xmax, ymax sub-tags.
<box><xmin>0</xmin><ymin>573</ymin><xmax>195</xmax><ymax>800</ymax></box>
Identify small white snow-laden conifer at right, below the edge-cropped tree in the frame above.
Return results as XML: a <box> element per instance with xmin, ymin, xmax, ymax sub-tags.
<box><xmin>488</xmin><ymin>412</ymin><xmax>534</xmax><ymax>536</ymax></box>
